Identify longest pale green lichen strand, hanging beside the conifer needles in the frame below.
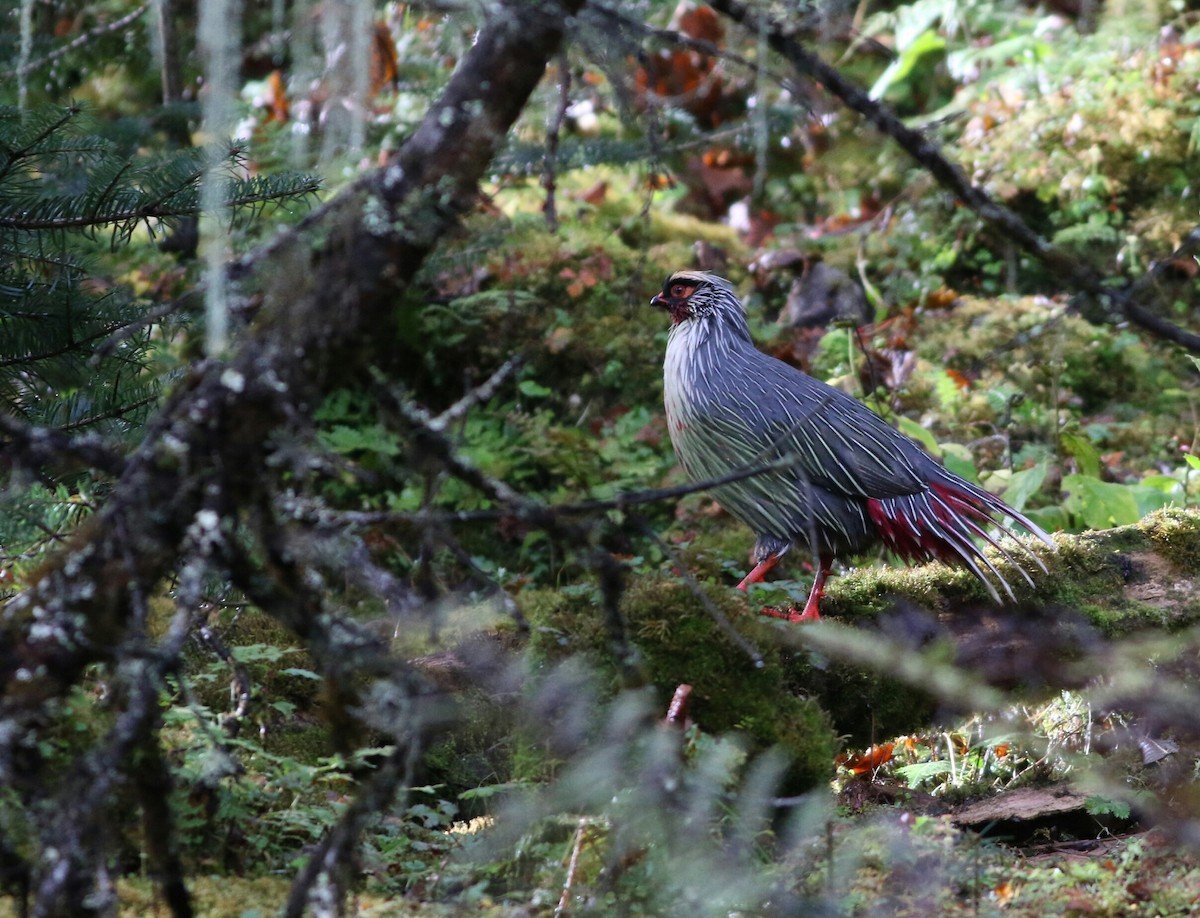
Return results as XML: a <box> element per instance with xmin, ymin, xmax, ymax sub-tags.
<box><xmin>197</xmin><ymin>0</ymin><xmax>241</xmax><ymax>355</ymax></box>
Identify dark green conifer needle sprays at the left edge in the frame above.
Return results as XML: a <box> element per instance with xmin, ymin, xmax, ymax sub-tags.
<box><xmin>0</xmin><ymin>106</ymin><xmax>318</xmax><ymax>436</ymax></box>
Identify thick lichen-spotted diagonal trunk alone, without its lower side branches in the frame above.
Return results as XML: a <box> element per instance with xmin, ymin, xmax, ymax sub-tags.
<box><xmin>0</xmin><ymin>0</ymin><xmax>582</xmax><ymax>736</ymax></box>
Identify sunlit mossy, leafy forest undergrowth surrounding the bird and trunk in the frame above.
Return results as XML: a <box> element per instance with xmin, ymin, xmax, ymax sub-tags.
<box><xmin>0</xmin><ymin>0</ymin><xmax>1200</xmax><ymax>916</ymax></box>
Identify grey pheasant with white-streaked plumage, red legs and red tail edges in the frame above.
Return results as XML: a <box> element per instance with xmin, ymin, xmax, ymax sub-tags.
<box><xmin>650</xmin><ymin>271</ymin><xmax>1054</xmax><ymax>619</ymax></box>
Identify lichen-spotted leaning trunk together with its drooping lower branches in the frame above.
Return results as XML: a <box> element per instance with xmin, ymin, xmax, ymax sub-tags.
<box><xmin>0</xmin><ymin>0</ymin><xmax>585</xmax><ymax>914</ymax></box>
